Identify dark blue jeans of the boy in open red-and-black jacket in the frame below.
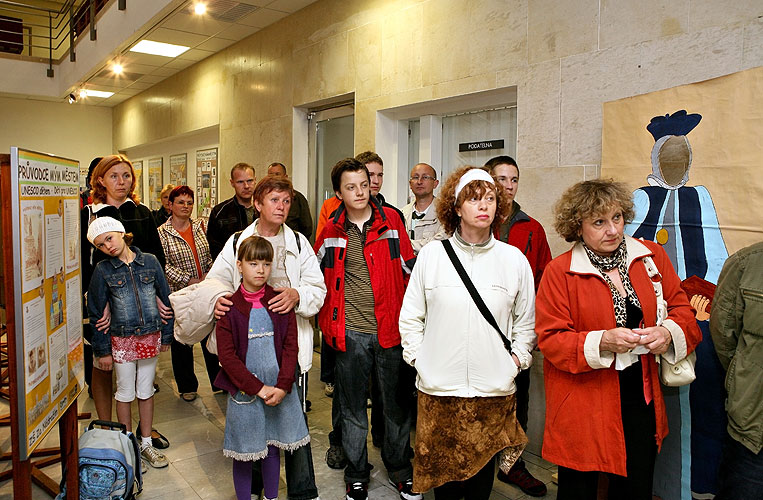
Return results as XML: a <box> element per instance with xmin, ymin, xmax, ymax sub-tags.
<box><xmin>334</xmin><ymin>330</ymin><xmax>413</xmax><ymax>483</ymax></box>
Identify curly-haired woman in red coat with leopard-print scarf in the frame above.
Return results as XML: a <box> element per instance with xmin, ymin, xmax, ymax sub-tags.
<box><xmin>535</xmin><ymin>180</ymin><xmax>702</xmax><ymax>500</ymax></box>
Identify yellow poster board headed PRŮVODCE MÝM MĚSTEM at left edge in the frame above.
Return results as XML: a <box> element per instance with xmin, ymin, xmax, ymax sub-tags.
<box><xmin>9</xmin><ymin>148</ymin><xmax>85</xmax><ymax>460</ymax></box>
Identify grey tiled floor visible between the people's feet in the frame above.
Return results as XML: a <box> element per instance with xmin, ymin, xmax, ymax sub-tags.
<box><xmin>0</xmin><ymin>346</ymin><xmax>556</xmax><ymax>500</ymax></box>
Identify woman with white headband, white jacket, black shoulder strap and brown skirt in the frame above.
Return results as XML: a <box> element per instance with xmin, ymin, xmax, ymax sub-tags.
<box><xmin>400</xmin><ymin>167</ymin><xmax>535</xmax><ymax>500</ymax></box>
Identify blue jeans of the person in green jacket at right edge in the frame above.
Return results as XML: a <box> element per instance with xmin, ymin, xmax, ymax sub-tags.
<box><xmin>715</xmin><ymin>432</ymin><xmax>763</xmax><ymax>500</ymax></box>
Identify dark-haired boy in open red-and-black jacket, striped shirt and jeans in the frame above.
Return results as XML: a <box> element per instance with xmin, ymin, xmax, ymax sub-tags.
<box><xmin>315</xmin><ymin>158</ymin><xmax>422</xmax><ymax>500</ymax></box>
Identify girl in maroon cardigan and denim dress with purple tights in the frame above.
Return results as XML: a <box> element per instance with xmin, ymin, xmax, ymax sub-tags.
<box><xmin>215</xmin><ymin>236</ymin><xmax>310</xmax><ymax>500</ymax></box>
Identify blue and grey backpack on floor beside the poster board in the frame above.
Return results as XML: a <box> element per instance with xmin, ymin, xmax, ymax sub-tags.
<box><xmin>56</xmin><ymin>420</ymin><xmax>143</xmax><ymax>500</ymax></box>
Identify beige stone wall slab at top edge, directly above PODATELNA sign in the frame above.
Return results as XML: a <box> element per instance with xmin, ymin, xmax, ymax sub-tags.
<box><xmin>468</xmin><ymin>0</ymin><xmax>527</xmax><ymax>75</ymax></box>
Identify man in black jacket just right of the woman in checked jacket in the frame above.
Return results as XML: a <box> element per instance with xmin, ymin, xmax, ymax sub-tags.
<box><xmin>207</xmin><ymin>163</ymin><xmax>257</xmax><ymax>260</ymax></box>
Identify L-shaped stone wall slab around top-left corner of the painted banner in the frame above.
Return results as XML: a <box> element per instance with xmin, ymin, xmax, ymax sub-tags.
<box><xmin>559</xmin><ymin>45</ymin><xmax>641</xmax><ymax>165</ymax></box>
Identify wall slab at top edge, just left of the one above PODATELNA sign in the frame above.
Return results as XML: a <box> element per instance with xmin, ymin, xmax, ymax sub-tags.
<box><xmin>420</xmin><ymin>0</ymin><xmax>473</xmax><ymax>85</ymax></box>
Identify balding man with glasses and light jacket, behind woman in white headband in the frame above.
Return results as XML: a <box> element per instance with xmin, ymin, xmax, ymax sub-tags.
<box><xmin>403</xmin><ymin>163</ymin><xmax>448</xmax><ymax>255</ymax></box>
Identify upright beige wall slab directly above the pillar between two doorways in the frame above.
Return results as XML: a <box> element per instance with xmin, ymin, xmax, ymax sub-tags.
<box><xmin>348</xmin><ymin>22</ymin><xmax>382</xmax><ymax>97</ymax></box>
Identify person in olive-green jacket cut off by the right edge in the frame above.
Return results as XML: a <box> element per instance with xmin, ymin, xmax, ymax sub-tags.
<box><xmin>710</xmin><ymin>242</ymin><xmax>763</xmax><ymax>500</ymax></box>
